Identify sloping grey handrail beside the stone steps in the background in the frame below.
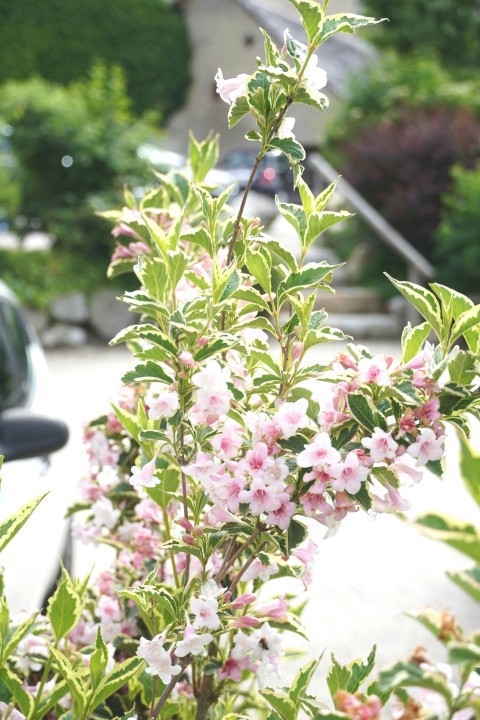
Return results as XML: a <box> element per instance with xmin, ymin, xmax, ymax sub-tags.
<box><xmin>308</xmin><ymin>152</ymin><xmax>435</xmax><ymax>282</ymax></box>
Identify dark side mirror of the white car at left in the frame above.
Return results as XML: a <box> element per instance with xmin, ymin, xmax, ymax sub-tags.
<box><xmin>0</xmin><ymin>410</ymin><xmax>68</xmax><ymax>461</ymax></box>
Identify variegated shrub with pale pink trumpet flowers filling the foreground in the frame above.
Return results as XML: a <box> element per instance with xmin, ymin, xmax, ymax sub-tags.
<box><xmin>0</xmin><ymin>0</ymin><xmax>480</xmax><ymax>720</ymax></box>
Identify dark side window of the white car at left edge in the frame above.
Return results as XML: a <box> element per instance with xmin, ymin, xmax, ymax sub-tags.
<box><xmin>0</xmin><ymin>299</ymin><xmax>30</xmax><ymax>411</ymax></box>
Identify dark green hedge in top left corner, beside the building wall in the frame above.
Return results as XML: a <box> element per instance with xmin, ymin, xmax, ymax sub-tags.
<box><xmin>0</xmin><ymin>0</ymin><xmax>189</xmax><ymax>116</ymax></box>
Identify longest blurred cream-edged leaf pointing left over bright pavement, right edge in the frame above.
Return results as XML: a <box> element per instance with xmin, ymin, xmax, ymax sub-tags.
<box><xmin>412</xmin><ymin>513</ymin><xmax>480</xmax><ymax>563</ymax></box>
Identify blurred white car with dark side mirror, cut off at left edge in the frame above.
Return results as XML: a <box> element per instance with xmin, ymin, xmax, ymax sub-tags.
<box><xmin>0</xmin><ymin>281</ymin><xmax>68</xmax><ymax>609</ymax></box>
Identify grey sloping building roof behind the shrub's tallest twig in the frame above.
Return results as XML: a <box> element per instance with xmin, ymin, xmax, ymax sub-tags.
<box><xmin>234</xmin><ymin>0</ymin><xmax>375</xmax><ymax>97</ymax></box>
